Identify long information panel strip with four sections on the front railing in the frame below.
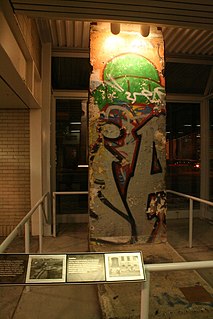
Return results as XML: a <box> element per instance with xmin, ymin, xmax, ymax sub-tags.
<box><xmin>0</xmin><ymin>252</ymin><xmax>145</xmax><ymax>285</ymax></box>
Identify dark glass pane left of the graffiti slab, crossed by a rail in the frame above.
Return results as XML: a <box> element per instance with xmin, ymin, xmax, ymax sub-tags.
<box><xmin>54</xmin><ymin>96</ymin><xmax>88</xmax><ymax>225</ymax></box>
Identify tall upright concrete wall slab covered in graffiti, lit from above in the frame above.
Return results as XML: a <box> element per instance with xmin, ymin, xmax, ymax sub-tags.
<box><xmin>89</xmin><ymin>23</ymin><xmax>166</xmax><ymax>243</ymax></box>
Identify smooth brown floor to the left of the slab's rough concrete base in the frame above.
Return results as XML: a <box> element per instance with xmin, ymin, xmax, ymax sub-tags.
<box><xmin>0</xmin><ymin>224</ymin><xmax>102</xmax><ymax>319</ymax></box>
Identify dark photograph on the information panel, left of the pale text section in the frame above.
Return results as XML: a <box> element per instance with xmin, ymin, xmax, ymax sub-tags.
<box><xmin>26</xmin><ymin>255</ymin><xmax>66</xmax><ymax>284</ymax></box>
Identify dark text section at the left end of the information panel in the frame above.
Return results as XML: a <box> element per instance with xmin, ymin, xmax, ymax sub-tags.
<box><xmin>0</xmin><ymin>254</ymin><xmax>28</xmax><ymax>284</ymax></box>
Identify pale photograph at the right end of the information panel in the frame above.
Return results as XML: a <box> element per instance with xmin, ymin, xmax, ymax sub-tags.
<box><xmin>105</xmin><ymin>252</ymin><xmax>145</xmax><ymax>281</ymax></box>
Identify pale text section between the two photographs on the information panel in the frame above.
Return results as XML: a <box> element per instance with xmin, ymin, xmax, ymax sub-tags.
<box><xmin>67</xmin><ymin>253</ymin><xmax>105</xmax><ymax>282</ymax></box>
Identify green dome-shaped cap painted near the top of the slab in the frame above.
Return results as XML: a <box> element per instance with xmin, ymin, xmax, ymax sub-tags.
<box><xmin>92</xmin><ymin>53</ymin><xmax>164</xmax><ymax>110</ymax></box>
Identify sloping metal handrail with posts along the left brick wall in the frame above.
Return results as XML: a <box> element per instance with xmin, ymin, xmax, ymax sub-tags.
<box><xmin>0</xmin><ymin>192</ymin><xmax>49</xmax><ymax>253</ymax></box>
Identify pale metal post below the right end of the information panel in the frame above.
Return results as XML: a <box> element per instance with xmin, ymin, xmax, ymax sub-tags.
<box><xmin>140</xmin><ymin>270</ymin><xmax>150</xmax><ymax>319</ymax></box>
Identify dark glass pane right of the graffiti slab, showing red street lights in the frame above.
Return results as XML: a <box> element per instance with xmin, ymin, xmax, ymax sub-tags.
<box><xmin>166</xmin><ymin>103</ymin><xmax>200</xmax><ymax>209</ymax></box>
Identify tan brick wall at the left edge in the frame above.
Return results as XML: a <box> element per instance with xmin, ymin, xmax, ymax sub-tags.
<box><xmin>0</xmin><ymin>110</ymin><xmax>30</xmax><ymax>236</ymax></box>
